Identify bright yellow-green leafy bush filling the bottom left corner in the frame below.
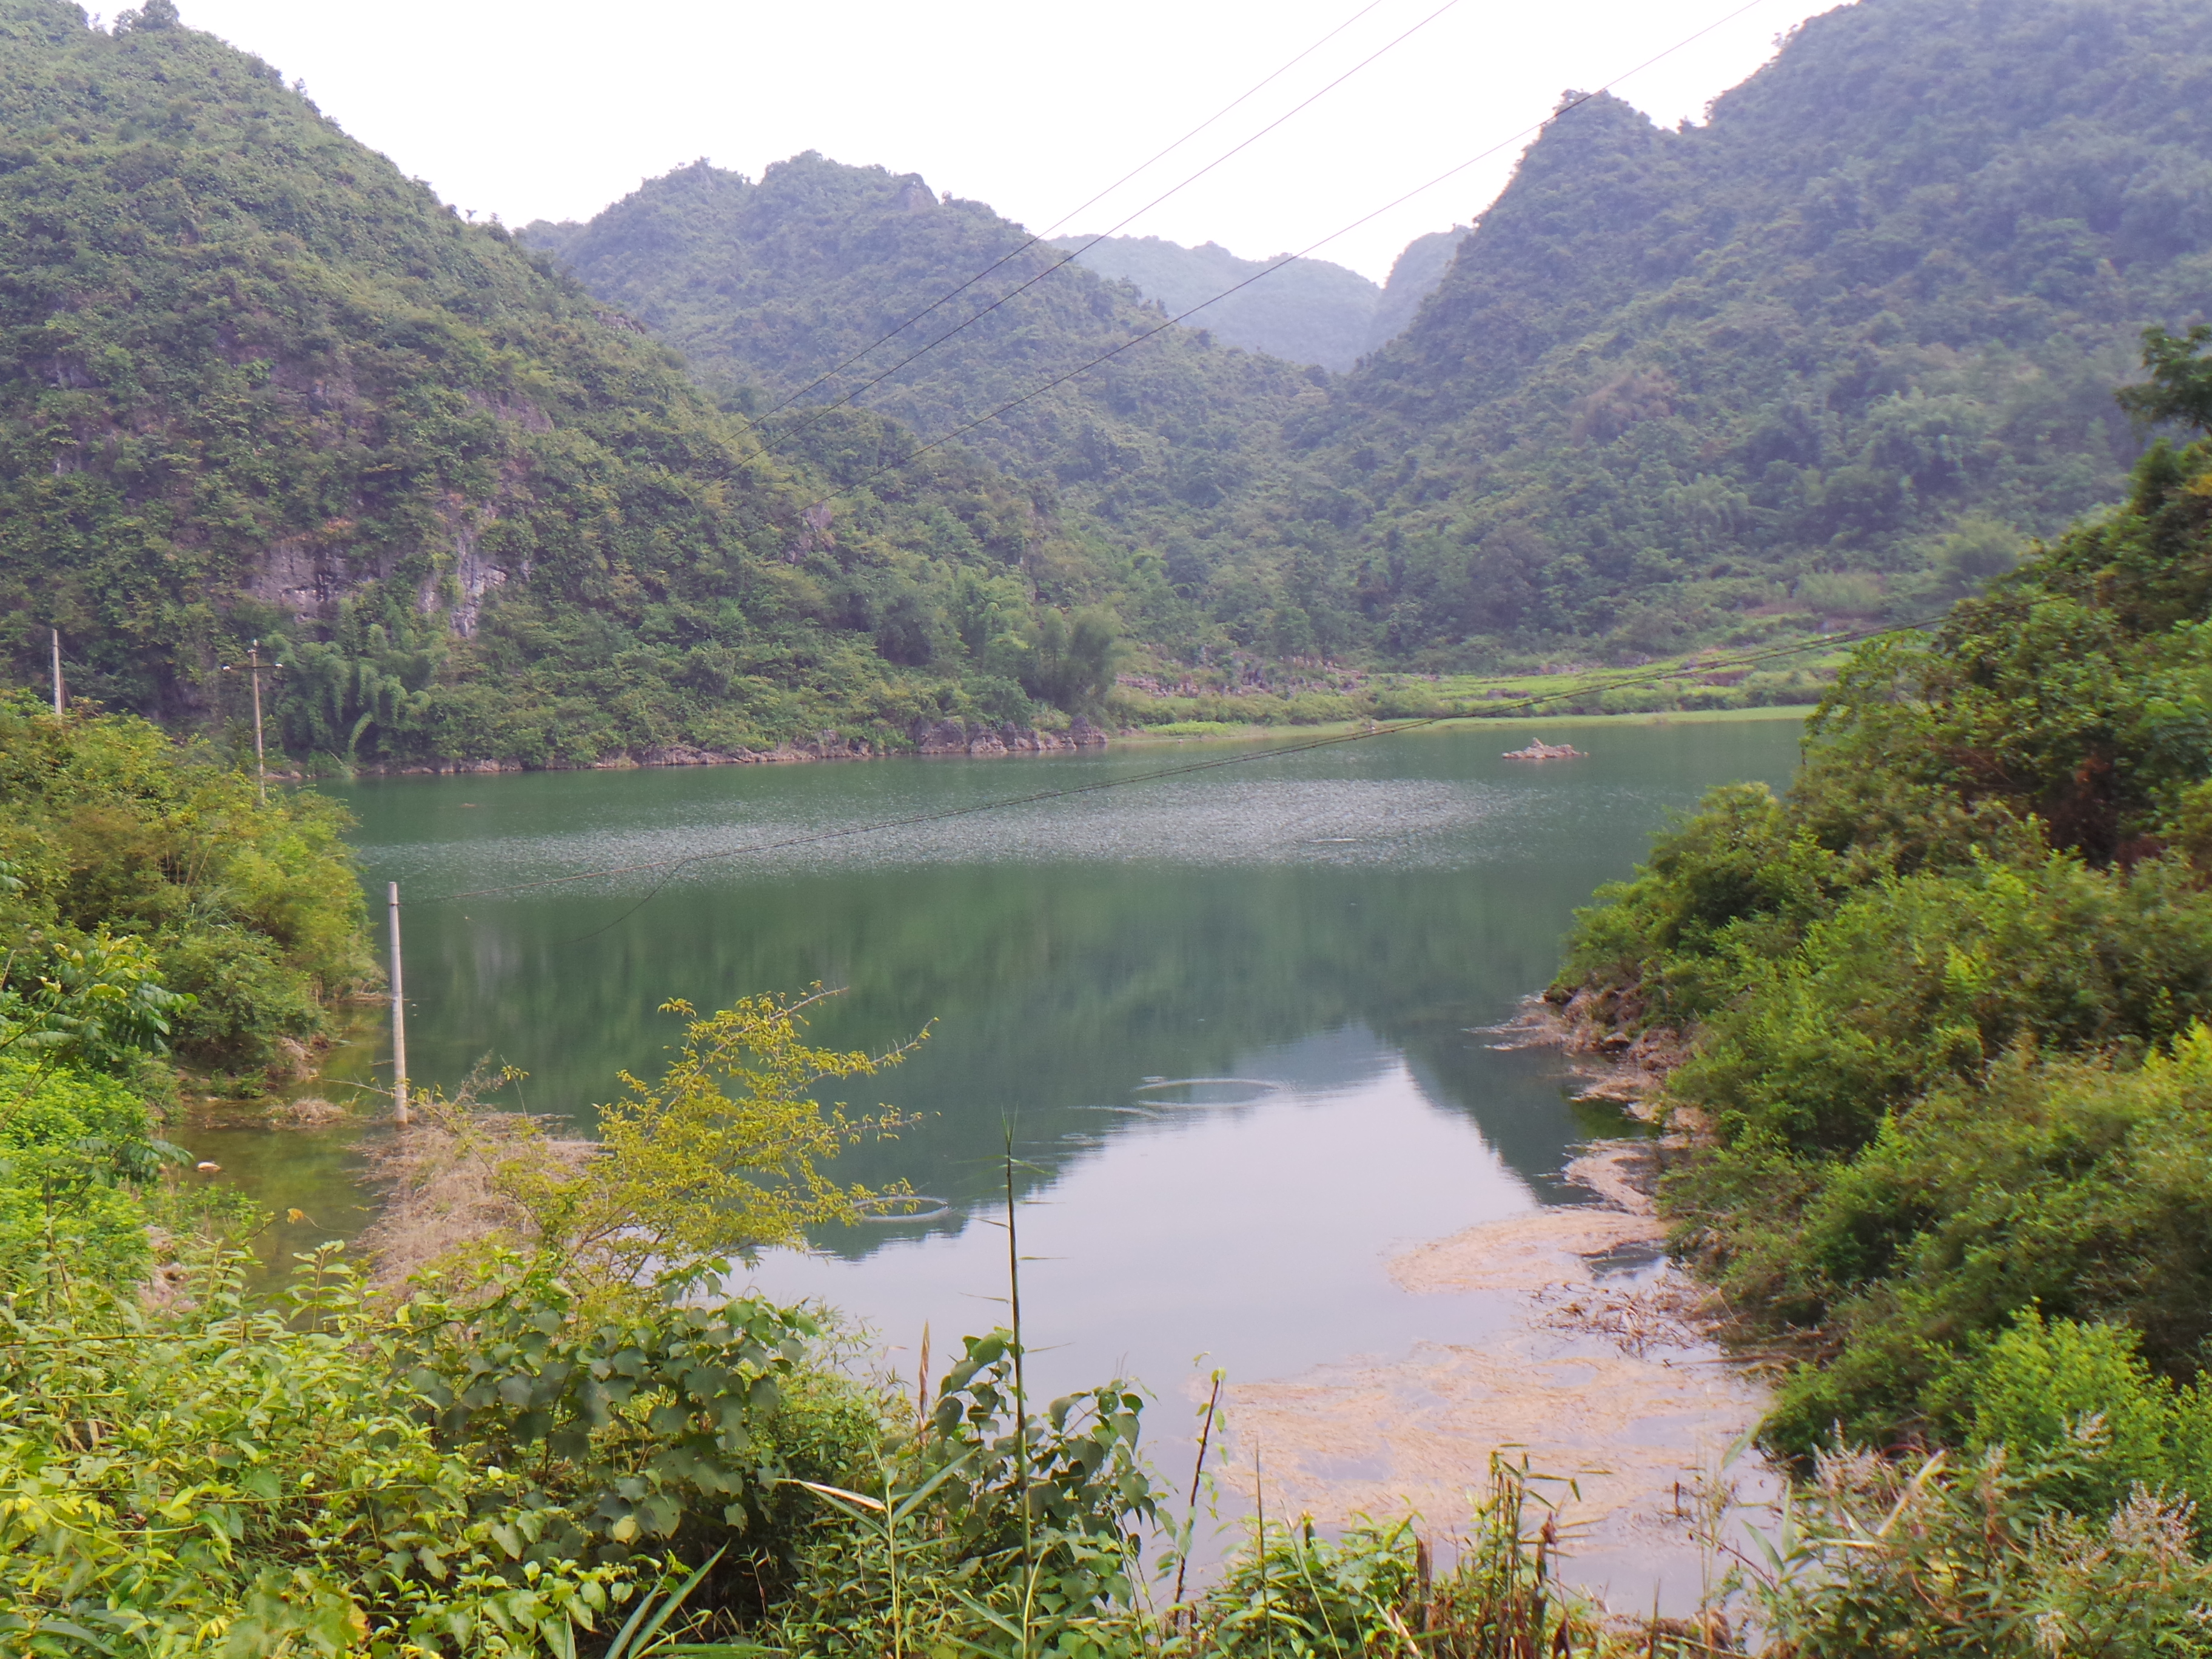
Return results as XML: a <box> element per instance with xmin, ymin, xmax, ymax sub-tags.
<box><xmin>0</xmin><ymin>1250</ymin><xmax>677</xmax><ymax>1659</ymax></box>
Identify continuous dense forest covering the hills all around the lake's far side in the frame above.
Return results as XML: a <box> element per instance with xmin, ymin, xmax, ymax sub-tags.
<box><xmin>0</xmin><ymin>0</ymin><xmax>2212</xmax><ymax>765</ymax></box>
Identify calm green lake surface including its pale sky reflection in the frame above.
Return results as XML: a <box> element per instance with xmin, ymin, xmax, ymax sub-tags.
<box><xmin>201</xmin><ymin>721</ymin><xmax>1798</xmax><ymax>1398</ymax></box>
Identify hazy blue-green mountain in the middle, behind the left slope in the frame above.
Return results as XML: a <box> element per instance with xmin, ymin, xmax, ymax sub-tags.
<box><xmin>520</xmin><ymin>153</ymin><xmax>1329</xmax><ymax>626</ymax></box>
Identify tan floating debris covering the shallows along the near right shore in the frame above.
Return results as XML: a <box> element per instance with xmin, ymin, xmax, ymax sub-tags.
<box><xmin>1223</xmin><ymin>1013</ymin><xmax>1783</xmax><ymax>1612</ymax></box>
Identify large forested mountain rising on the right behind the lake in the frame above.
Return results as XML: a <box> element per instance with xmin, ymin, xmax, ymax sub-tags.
<box><xmin>1301</xmin><ymin>0</ymin><xmax>2212</xmax><ymax>651</ymax></box>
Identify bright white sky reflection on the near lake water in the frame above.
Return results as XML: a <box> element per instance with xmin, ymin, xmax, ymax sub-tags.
<box><xmin>754</xmin><ymin>1027</ymin><xmax>1564</xmax><ymax>1393</ymax></box>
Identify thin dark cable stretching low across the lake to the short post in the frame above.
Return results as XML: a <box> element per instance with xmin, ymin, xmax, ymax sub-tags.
<box><xmin>405</xmin><ymin>615</ymin><xmax>1942</xmax><ymax>949</ymax></box>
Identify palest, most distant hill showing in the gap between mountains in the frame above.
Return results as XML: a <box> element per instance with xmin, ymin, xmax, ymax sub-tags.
<box><xmin>1055</xmin><ymin>236</ymin><xmax>1380</xmax><ymax>372</ymax></box>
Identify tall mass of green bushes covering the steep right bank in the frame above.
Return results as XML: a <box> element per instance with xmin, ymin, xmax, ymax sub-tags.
<box><xmin>1550</xmin><ymin>360</ymin><xmax>2212</xmax><ymax>1451</ymax></box>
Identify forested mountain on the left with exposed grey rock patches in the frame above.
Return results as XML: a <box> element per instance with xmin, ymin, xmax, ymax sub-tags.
<box><xmin>0</xmin><ymin>0</ymin><xmax>1141</xmax><ymax>763</ymax></box>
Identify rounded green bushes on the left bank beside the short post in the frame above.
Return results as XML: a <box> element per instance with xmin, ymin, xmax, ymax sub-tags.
<box><xmin>0</xmin><ymin>697</ymin><xmax>374</xmax><ymax>1073</ymax></box>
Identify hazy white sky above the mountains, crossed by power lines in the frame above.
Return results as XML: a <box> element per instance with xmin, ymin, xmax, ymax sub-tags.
<box><xmin>160</xmin><ymin>0</ymin><xmax>1827</xmax><ymax>281</ymax></box>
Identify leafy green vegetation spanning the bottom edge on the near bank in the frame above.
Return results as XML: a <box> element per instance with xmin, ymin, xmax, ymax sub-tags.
<box><xmin>13</xmin><ymin>982</ymin><xmax>2212</xmax><ymax>1659</ymax></box>
